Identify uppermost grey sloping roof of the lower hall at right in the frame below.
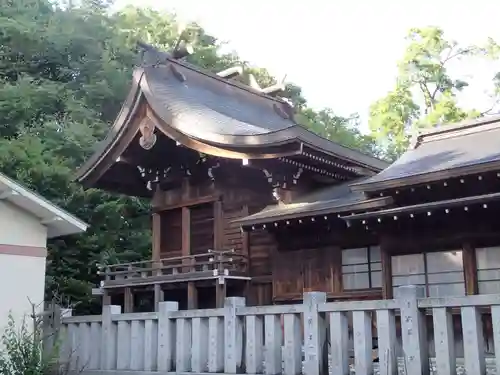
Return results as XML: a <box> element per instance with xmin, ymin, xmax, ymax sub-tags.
<box><xmin>351</xmin><ymin>115</ymin><xmax>500</xmax><ymax>192</ymax></box>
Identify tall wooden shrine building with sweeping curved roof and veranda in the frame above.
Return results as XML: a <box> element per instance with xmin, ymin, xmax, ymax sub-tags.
<box><xmin>77</xmin><ymin>41</ymin><xmax>387</xmax><ymax>311</ymax></box>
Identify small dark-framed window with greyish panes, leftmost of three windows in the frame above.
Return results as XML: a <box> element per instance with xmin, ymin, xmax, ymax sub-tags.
<box><xmin>342</xmin><ymin>246</ymin><xmax>382</xmax><ymax>290</ymax></box>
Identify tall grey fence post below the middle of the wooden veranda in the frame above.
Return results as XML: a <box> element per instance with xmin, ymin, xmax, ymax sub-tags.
<box><xmin>156</xmin><ymin>301</ymin><xmax>179</xmax><ymax>372</ymax></box>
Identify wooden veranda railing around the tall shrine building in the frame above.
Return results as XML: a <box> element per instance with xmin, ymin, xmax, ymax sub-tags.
<box><xmin>99</xmin><ymin>250</ymin><xmax>247</xmax><ymax>287</ymax></box>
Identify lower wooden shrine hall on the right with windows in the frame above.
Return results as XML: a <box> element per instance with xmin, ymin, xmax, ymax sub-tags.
<box><xmin>239</xmin><ymin>116</ymin><xmax>500</xmax><ymax>306</ymax></box>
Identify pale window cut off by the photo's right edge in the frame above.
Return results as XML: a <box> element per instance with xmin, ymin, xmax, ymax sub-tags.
<box><xmin>476</xmin><ymin>247</ymin><xmax>500</xmax><ymax>294</ymax></box>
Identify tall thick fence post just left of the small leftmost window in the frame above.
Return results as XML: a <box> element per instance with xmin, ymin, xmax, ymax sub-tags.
<box><xmin>303</xmin><ymin>292</ymin><xmax>328</xmax><ymax>375</ymax></box>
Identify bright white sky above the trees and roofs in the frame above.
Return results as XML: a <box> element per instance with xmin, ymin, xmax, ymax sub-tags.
<box><xmin>112</xmin><ymin>0</ymin><xmax>500</xmax><ymax>123</ymax></box>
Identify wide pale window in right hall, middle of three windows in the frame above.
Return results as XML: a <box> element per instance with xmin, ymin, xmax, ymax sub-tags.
<box><xmin>392</xmin><ymin>251</ymin><xmax>465</xmax><ymax>297</ymax></box>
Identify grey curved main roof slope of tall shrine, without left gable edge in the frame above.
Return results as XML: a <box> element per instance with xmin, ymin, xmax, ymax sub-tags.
<box><xmin>140</xmin><ymin>60</ymin><xmax>388</xmax><ymax>171</ymax></box>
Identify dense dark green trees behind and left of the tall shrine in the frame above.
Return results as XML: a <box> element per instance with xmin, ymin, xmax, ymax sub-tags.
<box><xmin>0</xmin><ymin>0</ymin><xmax>376</xmax><ymax>312</ymax></box>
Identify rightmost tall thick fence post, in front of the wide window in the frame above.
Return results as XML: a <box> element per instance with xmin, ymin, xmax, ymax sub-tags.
<box><xmin>398</xmin><ymin>285</ymin><xmax>430</xmax><ymax>375</ymax></box>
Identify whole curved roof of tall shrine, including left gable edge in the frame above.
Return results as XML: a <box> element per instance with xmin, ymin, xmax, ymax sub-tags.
<box><xmin>77</xmin><ymin>52</ymin><xmax>387</xmax><ymax>187</ymax></box>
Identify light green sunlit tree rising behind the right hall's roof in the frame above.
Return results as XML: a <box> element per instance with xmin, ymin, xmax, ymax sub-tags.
<box><xmin>369</xmin><ymin>27</ymin><xmax>485</xmax><ymax>158</ymax></box>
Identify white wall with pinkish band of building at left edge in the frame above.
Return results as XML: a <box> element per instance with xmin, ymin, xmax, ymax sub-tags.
<box><xmin>0</xmin><ymin>201</ymin><xmax>47</xmax><ymax>333</ymax></box>
